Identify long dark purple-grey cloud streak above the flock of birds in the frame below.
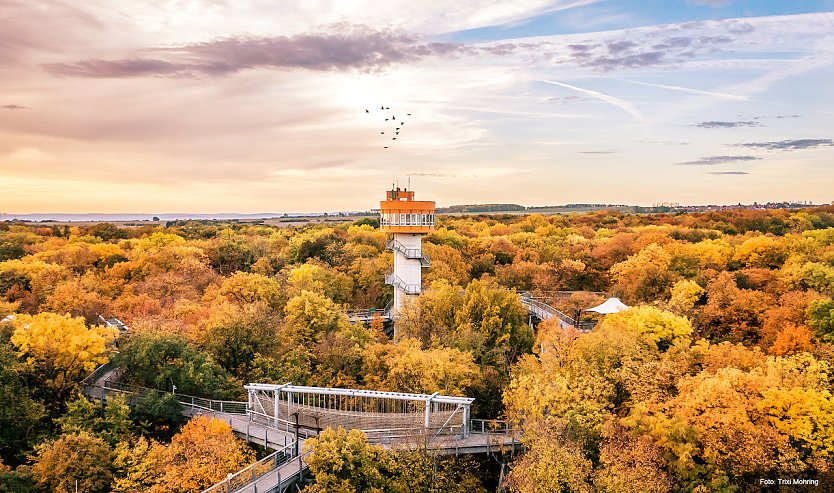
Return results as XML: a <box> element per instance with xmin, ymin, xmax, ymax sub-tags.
<box><xmin>45</xmin><ymin>26</ymin><xmax>468</xmax><ymax>78</ymax></box>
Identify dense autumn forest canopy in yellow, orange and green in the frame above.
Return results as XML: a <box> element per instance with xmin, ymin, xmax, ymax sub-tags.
<box><xmin>0</xmin><ymin>207</ymin><xmax>834</xmax><ymax>493</ymax></box>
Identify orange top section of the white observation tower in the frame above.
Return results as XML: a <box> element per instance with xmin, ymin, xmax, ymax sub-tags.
<box><xmin>379</xmin><ymin>187</ymin><xmax>434</xmax><ymax>233</ymax></box>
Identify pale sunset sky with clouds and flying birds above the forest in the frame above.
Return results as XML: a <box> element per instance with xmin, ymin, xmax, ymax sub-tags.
<box><xmin>0</xmin><ymin>0</ymin><xmax>834</xmax><ymax>213</ymax></box>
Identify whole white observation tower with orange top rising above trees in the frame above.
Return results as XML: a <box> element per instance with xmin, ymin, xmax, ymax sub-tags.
<box><xmin>379</xmin><ymin>186</ymin><xmax>434</xmax><ymax>331</ymax></box>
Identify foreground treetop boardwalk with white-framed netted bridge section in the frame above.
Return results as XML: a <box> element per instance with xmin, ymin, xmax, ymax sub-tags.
<box><xmin>83</xmin><ymin>363</ymin><xmax>521</xmax><ymax>493</ymax></box>
